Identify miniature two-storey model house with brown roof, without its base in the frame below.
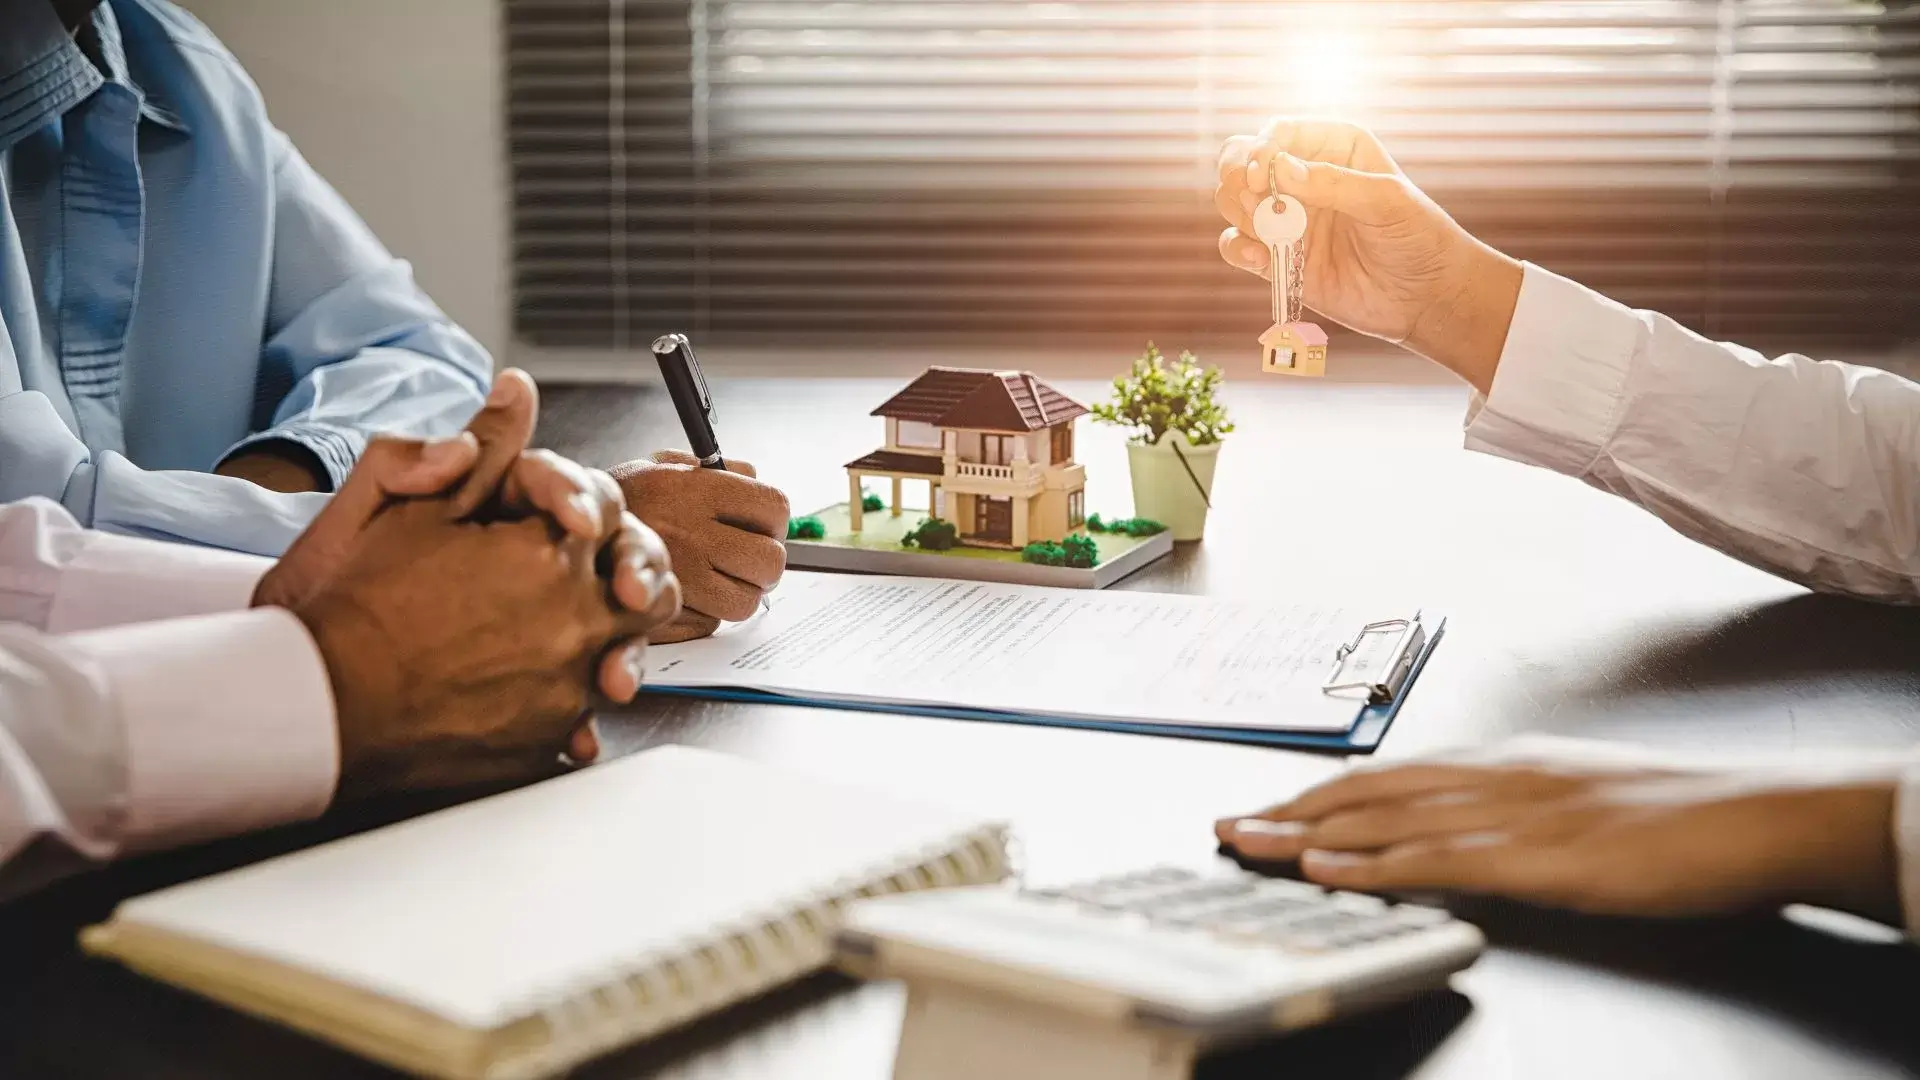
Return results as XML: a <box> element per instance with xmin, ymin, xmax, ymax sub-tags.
<box><xmin>847</xmin><ymin>367</ymin><xmax>1087</xmax><ymax>550</ymax></box>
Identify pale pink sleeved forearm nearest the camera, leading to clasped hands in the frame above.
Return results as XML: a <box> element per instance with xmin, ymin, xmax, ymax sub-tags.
<box><xmin>0</xmin><ymin>609</ymin><xmax>338</xmax><ymax>897</ymax></box>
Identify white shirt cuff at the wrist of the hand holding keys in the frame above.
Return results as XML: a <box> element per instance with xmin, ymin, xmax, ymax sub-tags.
<box><xmin>1467</xmin><ymin>263</ymin><xmax>1649</xmax><ymax>477</ymax></box>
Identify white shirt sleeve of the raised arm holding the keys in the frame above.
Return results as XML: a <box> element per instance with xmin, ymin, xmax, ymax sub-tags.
<box><xmin>1467</xmin><ymin>265</ymin><xmax>1920</xmax><ymax>603</ymax></box>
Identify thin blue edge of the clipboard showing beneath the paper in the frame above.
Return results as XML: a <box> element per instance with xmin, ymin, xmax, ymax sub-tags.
<box><xmin>643</xmin><ymin>617</ymin><xmax>1446</xmax><ymax>753</ymax></box>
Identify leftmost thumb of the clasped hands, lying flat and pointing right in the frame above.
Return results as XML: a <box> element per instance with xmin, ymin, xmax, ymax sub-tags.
<box><xmin>282</xmin><ymin>432</ymin><xmax>480</xmax><ymax>565</ymax></box>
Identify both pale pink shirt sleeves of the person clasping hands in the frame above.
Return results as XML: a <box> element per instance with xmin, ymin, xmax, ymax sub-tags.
<box><xmin>0</xmin><ymin>500</ymin><xmax>340</xmax><ymax>897</ymax></box>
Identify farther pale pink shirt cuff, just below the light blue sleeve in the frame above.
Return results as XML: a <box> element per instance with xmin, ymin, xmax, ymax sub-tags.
<box><xmin>46</xmin><ymin>530</ymin><xmax>273</xmax><ymax>634</ymax></box>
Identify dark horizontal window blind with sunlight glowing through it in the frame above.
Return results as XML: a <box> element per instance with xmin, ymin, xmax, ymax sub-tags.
<box><xmin>505</xmin><ymin>0</ymin><xmax>1920</xmax><ymax>348</ymax></box>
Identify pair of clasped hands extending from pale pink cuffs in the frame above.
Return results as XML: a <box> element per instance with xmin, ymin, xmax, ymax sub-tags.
<box><xmin>253</xmin><ymin>371</ymin><xmax>680</xmax><ymax>796</ymax></box>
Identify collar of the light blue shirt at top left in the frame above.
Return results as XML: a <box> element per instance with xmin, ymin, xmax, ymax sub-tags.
<box><xmin>0</xmin><ymin>0</ymin><xmax>186</xmax><ymax>152</ymax></box>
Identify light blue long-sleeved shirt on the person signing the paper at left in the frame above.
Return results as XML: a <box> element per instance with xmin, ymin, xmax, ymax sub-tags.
<box><xmin>0</xmin><ymin>0</ymin><xmax>492</xmax><ymax>555</ymax></box>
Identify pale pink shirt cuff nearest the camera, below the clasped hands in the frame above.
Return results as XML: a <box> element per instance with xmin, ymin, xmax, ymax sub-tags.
<box><xmin>67</xmin><ymin>607</ymin><xmax>340</xmax><ymax>851</ymax></box>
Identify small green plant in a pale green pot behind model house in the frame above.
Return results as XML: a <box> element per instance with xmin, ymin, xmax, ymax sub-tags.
<box><xmin>1092</xmin><ymin>344</ymin><xmax>1233</xmax><ymax>540</ymax></box>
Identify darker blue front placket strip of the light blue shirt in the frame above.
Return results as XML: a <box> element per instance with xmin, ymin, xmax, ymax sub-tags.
<box><xmin>60</xmin><ymin>83</ymin><xmax>146</xmax><ymax>450</ymax></box>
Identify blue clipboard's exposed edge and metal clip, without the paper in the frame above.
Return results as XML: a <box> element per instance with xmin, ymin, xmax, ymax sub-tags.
<box><xmin>643</xmin><ymin>611</ymin><xmax>1446</xmax><ymax>753</ymax></box>
